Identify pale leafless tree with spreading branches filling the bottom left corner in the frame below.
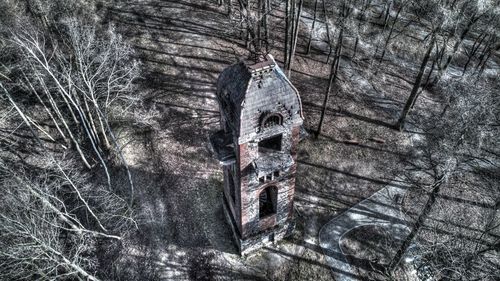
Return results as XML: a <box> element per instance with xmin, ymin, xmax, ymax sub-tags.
<box><xmin>0</xmin><ymin>157</ymin><xmax>134</xmax><ymax>280</ymax></box>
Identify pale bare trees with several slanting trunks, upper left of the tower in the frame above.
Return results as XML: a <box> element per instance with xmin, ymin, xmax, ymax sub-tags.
<box><xmin>2</xmin><ymin>19</ymin><xmax>138</xmax><ymax>197</ymax></box>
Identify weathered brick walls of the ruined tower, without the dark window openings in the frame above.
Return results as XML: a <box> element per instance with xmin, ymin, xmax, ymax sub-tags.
<box><xmin>214</xmin><ymin>57</ymin><xmax>302</xmax><ymax>249</ymax></box>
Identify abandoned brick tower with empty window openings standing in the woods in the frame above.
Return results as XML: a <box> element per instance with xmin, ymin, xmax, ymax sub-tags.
<box><xmin>210</xmin><ymin>55</ymin><xmax>303</xmax><ymax>254</ymax></box>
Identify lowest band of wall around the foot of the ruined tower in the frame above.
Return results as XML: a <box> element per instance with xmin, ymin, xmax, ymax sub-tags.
<box><xmin>222</xmin><ymin>196</ymin><xmax>295</xmax><ymax>256</ymax></box>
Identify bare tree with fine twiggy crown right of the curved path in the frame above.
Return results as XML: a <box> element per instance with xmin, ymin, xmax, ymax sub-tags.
<box><xmin>392</xmin><ymin>76</ymin><xmax>500</xmax><ymax>280</ymax></box>
